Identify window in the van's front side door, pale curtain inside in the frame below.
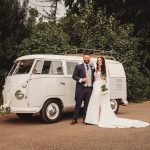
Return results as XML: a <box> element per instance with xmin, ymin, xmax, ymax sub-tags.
<box><xmin>41</xmin><ymin>61</ymin><xmax>63</xmax><ymax>75</ymax></box>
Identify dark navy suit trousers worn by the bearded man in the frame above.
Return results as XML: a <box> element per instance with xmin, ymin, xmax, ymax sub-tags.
<box><xmin>73</xmin><ymin>87</ymin><xmax>93</xmax><ymax>120</ymax></box>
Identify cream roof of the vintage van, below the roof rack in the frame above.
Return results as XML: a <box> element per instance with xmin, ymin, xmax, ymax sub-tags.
<box><xmin>15</xmin><ymin>54</ymin><xmax>119</xmax><ymax>63</ymax></box>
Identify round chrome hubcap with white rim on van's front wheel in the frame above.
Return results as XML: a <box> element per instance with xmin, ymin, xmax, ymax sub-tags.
<box><xmin>46</xmin><ymin>103</ymin><xmax>59</xmax><ymax>120</ymax></box>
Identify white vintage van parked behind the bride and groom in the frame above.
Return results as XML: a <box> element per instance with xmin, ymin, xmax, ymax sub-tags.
<box><xmin>0</xmin><ymin>55</ymin><xmax>127</xmax><ymax>123</ymax></box>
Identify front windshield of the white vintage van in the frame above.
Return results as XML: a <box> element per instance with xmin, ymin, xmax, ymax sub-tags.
<box><xmin>9</xmin><ymin>59</ymin><xmax>34</xmax><ymax>75</ymax></box>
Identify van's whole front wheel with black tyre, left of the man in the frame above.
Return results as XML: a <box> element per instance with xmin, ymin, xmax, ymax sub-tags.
<box><xmin>40</xmin><ymin>99</ymin><xmax>62</xmax><ymax>123</ymax></box>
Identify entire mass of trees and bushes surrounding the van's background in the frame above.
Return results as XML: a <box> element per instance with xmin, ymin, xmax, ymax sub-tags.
<box><xmin>0</xmin><ymin>0</ymin><xmax>150</xmax><ymax>101</ymax></box>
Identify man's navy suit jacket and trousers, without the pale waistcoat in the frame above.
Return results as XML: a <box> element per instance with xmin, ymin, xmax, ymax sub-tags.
<box><xmin>72</xmin><ymin>63</ymin><xmax>95</xmax><ymax>120</ymax></box>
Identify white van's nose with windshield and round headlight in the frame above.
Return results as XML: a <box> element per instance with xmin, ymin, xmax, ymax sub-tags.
<box><xmin>6</xmin><ymin>59</ymin><xmax>34</xmax><ymax>109</ymax></box>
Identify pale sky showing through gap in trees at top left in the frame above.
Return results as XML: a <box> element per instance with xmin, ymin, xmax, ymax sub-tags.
<box><xmin>29</xmin><ymin>0</ymin><xmax>65</xmax><ymax>18</ymax></box>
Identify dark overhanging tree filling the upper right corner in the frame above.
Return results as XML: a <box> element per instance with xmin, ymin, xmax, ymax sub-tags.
<box><xmin>64</xmin><ymin>0</ymin><xmax>150</xmax><ymax>77</ymax></box>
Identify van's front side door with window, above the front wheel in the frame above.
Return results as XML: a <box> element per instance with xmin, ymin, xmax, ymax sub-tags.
<box><xmin>28</xmin><ymin>60</ymin><xmax>66</xmax><ymax>107</ymax></box>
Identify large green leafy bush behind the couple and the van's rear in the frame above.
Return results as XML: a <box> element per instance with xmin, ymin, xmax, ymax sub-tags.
<box><xmin>60</xmin><ymin>4</ymin><xmax>150</xmax><ymax>101</ymax></box>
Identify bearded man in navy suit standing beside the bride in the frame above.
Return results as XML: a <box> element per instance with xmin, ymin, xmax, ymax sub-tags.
<box><xmin>71</xmin><ymin>54</ymin><xmax>95</xmax><ymax>125</ymax></box>
